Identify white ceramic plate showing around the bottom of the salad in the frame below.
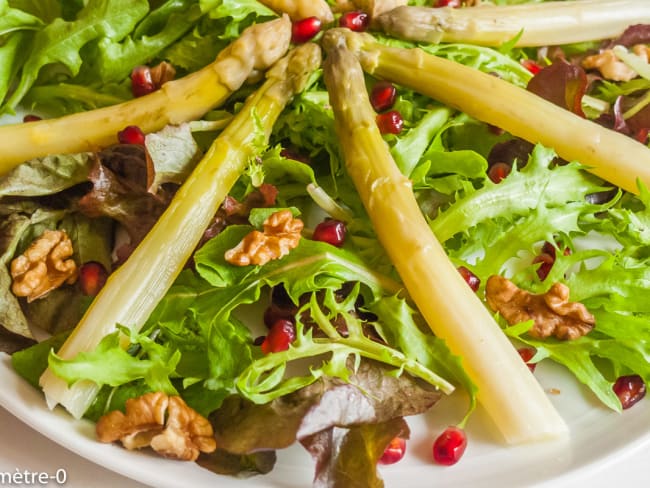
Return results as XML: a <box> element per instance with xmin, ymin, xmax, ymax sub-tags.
<box><xmin>0</xmin><ymin>354</ymin><xmax>650</xmax><ymax>488</ymax></box>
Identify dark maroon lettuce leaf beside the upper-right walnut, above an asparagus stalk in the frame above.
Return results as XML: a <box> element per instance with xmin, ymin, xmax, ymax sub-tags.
<box><xmin>527</xmin><ymin>60</ymin><xmax>588</xmax><ymax>117</ymax></box>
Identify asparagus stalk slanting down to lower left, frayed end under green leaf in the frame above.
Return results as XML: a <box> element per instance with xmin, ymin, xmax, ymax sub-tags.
<box><xmin>40</xmin><ymin>43</ymin><xmax>321</xmax><ymax>417</ymax></box>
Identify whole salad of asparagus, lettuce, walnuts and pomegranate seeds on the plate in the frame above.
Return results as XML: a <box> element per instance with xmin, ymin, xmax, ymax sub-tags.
<box><xmin>0</xmin><ymin>0</ymin><xmax>650</xmax><ymax>486</ymax></box>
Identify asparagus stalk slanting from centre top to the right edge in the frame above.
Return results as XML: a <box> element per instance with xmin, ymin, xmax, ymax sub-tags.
<box><xmin>340</xmin><ymin>29</ymin><xmax>650</xmax><ymax>193</ymax></box>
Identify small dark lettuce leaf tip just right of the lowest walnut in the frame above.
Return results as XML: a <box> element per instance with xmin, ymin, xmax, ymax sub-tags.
<box><xmin>196</xmin><ymin>449</ymin><xmax>277</xmax><ymax>478</ymax></box>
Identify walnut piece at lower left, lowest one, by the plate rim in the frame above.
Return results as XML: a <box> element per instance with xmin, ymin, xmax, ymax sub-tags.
<box><xmin>96</xmin><ymin>392</ymin><xmax>217</xmax><ymax>461</ymax></box>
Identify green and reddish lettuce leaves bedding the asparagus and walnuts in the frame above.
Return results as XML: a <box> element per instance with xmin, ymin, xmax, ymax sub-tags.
<box><xmin>0</xmin><ymin>0</ymin><xmax>650</xmax><ymax>486</ymax></box>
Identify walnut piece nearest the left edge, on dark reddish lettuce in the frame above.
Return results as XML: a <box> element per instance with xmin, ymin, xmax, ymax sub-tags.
<box><xmin>10</xmin><ymin>230</ymin><xmax>77</xmax><ymax>302</ymax></box>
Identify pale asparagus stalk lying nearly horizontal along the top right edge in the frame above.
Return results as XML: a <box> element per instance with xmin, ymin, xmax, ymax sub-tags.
<box><xmin>376</xmin><ymin>0</ymin><xmax>650</xmax><ymax>47</ymax></box>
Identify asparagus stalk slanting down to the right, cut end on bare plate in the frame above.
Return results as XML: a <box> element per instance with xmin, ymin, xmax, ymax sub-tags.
<box><xmin>324</xmin><ymin>30</ymin><xmax>566</xmax><ymax>443</ymax></box>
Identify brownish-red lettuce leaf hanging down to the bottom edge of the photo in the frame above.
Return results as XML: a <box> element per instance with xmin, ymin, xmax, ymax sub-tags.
<box><xmin>300</xmin><ymin>417</ymin><xmax>409</xmax><ymax>488</ymax></box>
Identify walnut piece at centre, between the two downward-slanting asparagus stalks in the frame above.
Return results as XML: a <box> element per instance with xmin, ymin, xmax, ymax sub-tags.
<box><xmin>225</xmin><ymin>210</ymin><xmax>303</xmax><ymax>266</ymax></box>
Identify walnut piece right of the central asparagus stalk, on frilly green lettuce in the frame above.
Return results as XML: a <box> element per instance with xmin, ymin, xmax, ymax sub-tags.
<box><xmin>485</xmin><ymin>275</ymin><xmax>596</xmax><ymax>340</ymax></box>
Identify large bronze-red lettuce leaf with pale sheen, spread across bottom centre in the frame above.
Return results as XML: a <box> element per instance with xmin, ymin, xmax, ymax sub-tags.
<box><xmin>210</xmin><ymin>360</ymin><xmax>440</xmax><ymax>454</ymax></box>
